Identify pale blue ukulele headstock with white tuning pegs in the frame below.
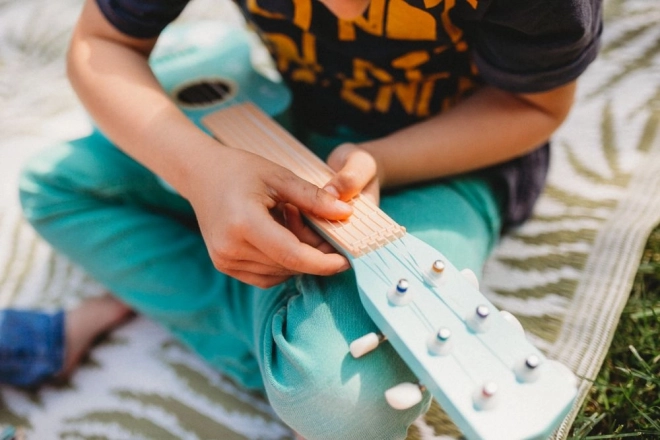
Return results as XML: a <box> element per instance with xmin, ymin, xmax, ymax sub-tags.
<box><xmin>351</xmin><ymin>234</ymin><xmax>577</xmax><ymax>440</ymax></box>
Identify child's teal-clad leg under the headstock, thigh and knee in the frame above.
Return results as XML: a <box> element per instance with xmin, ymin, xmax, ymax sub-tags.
<box><xmin>254</xmin><ymin>180</ymin><xmax>500</xmax><ymax>440</ymax></box>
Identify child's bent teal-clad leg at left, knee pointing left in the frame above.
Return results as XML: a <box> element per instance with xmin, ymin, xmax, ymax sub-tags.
<box><xmin>20</xmin><ymin>134</ymin><xmax>262</xmax><ymax>388</ymax></box>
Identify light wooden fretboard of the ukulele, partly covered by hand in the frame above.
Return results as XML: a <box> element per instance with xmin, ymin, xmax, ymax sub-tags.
<box><xmin>202</xmin><ymin>103</ymin><xmax>405</xmax><ymax>258</ymax></box>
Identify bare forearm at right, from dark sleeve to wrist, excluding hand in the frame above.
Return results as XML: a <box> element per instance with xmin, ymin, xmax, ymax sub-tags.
<box><xmin>359</xmin><ymin>83</ymin><xmax>575</xmax><ymax>187</ymax></box>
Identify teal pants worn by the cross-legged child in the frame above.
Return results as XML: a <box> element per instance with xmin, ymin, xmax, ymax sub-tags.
<box><xmin>20</xmin><ymin>124</ymin><xmax>501</xmax><ymax>440</ymax></box>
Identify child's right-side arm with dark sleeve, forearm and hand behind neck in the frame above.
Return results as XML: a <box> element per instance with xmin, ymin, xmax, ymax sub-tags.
<box><xmin>322</xmin><ymin>0</ymin><xmax>602</xmax><ymax>198</ymax></box>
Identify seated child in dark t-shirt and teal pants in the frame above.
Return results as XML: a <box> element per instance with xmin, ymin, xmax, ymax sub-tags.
<box><xmin>21</xmin><ymin>0</ymin><xmax>601</xmax><ymax>439</ymax></box>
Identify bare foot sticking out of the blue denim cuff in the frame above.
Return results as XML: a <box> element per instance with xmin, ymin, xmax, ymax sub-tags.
<box><xmin>58</xmin><ymin>294</ymin><xmax>132</xmax><ymax>380</ymax></box>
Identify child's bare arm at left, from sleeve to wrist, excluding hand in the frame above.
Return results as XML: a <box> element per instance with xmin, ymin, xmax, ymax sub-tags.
<box><xmin>67</xmin><ymin>2</ymin><xmax>224</xmax><ymax>198</ymax></box>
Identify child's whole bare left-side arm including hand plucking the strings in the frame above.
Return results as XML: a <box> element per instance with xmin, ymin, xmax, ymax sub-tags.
<box><xmin>68</xmin><ymin>0</ymin><xmax>351</xmax><ymax>287</ymax></box>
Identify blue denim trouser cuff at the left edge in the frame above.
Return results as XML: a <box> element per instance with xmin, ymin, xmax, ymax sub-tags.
<box><xmin>0</xmin><ymin>309</ymin><xmax>64</xmax><ymax>387</ymax></box>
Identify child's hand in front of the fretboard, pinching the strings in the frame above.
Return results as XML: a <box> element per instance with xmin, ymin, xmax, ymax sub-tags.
<box><xmin>187</xmin><ymin>148</ymin><xmax>352</xmax><ymax>288</ymax></box>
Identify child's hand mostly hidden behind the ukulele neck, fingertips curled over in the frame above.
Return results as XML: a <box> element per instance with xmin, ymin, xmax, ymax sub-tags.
<box><xmin>323</xmin><ymin>143</ymin><xmax>380</xmax><ymax>205</ymax></box>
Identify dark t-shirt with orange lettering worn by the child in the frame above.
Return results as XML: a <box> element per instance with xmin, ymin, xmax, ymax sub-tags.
<box><xmin>97</xmin><ymin>0</ymin><xmax>602</xmax><ymax>226</ymax></box>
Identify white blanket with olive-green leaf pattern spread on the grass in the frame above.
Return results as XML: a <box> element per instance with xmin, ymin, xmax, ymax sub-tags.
<box><xmin>0</xmin><ymin>0</ymin><xmax>660</xmax><ymax>440</ymax></box>
